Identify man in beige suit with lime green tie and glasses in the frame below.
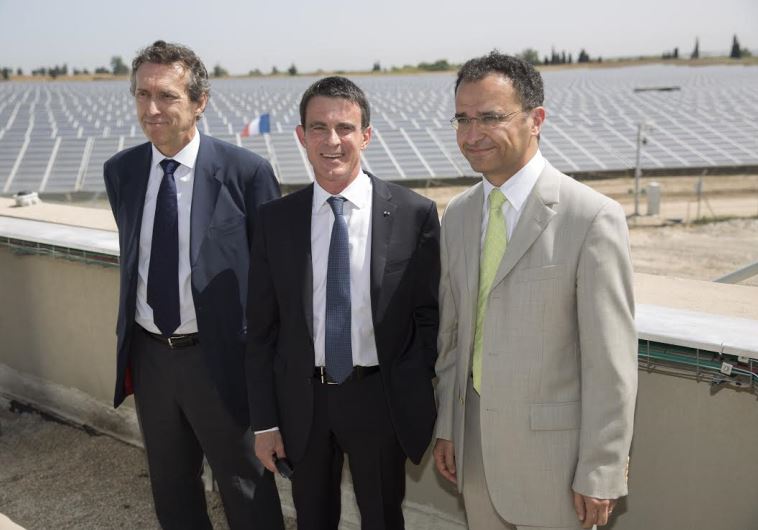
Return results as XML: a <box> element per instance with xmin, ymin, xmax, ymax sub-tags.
<box><xmin>434</xmin><ymin>52</ymin><xmax>637</xmax><ymax>530</ymax></box>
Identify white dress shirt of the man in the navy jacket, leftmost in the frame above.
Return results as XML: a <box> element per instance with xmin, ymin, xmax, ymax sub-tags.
<box><xmin>134</xmin><ymin>129</ymin><xmax>200</xmax><ymax>335</ymax></box>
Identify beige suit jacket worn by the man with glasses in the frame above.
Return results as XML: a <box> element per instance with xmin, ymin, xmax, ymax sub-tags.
<box><xmin>436</xmin><ymin>164</ymin><xmax>637</xmax><ymax>526</ymax></box>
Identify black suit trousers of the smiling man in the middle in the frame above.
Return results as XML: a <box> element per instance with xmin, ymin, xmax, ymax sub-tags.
<box><xmin>292</xmin><ymin>372</ymin><xmax>406</xmax><ymax>530</ymax></box>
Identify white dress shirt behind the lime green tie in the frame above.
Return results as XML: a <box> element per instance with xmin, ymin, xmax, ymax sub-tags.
<box><xmin>481</xmin><ymin>149</ymin><xmax>546</xmax><ymax>243</ymax></box>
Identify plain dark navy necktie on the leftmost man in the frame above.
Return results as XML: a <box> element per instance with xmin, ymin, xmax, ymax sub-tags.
<box><xmin>147</xmin><ymin>158</ymin><xmax>180</xmax><ymax>337</ymax></box>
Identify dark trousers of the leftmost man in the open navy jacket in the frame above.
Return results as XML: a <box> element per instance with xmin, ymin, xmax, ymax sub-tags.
<box><xmin>131</xmin><ymin>325</ymin><xmax>284</xmax><ymax>530</ymax></box>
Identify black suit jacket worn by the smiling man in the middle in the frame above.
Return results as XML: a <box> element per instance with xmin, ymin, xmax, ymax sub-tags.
<box><xmin>246</xmin><ymin>175</ymin><xmax>440</xmax><ymax>462</ymax></box>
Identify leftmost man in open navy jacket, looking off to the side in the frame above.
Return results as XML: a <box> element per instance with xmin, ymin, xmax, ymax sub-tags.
<box><xmin>104</xmin><ymin>41</ymin><xmax>283</xmax><ymax>530</ymax></box>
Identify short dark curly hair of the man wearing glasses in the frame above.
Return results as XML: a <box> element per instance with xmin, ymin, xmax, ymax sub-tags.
<box><xmin>455</xmin><ymin>50</ymin><xmax>545</xmax><ymax>110</ymax></box>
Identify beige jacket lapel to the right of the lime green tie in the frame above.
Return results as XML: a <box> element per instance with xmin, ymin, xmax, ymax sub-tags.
<box><xmin>492</xmin><ymin>165</ymin><xmax>559</xmax><ymax>289</ymax></box>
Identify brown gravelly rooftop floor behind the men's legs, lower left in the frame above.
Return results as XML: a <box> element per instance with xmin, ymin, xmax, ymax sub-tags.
<box><xmin>0</xmin><ymin>398</ymin><xmax>295</xmax><ymax>530</ymax></box>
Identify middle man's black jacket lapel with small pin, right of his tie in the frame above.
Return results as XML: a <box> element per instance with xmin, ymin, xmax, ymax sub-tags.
<box><xmin>367</xmin><ymin>172</ymin><xmax>397</xmax><ymax>322</ymax></box>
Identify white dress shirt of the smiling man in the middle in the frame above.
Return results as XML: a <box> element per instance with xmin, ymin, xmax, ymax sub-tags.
<box><xmin>311</xmin><ymin>171</ymin><xmax>379</xmax><ymax>366</ymax></box>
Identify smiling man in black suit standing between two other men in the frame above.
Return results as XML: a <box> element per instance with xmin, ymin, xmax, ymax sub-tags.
<box><xmin>246</xmin><ymin>77</ymin><xmax>440</xmax><ymax>530</ymax></box>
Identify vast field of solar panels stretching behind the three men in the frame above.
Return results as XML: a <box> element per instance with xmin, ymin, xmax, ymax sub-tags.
<box><xmin>0</xmin><ymin>65</ymin><xmax>758</xmax><ymax>194</ymax></box>
